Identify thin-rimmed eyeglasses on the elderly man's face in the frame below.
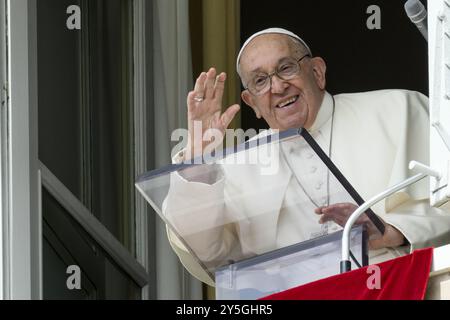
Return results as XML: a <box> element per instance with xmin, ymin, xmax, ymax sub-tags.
<box><xmin>245</xmin><ymin>54</ymin><xmax>311</xmax><ymax>96</ymax></box>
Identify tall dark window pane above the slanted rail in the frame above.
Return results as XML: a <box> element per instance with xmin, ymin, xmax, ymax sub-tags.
<box><xmin>37</xmin><ymin>0</ymin><xmax>135</xmax><ymax>253</ymax></box>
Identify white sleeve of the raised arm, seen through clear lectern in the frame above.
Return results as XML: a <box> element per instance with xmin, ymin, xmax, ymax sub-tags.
<box><xmin>163</xmin><ymin>149</ymin><xmax>236</xmax><ymax>274</ymax></box>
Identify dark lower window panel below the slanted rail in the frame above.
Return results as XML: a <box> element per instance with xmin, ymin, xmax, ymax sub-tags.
<box><xmin>42</xmin><ymin>188</ymin><xmax>141</xmax><ymax>299</ymax></box>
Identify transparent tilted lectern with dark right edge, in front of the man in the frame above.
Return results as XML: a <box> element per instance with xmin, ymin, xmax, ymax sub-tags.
<box><xmin>136</xmin><ymin>129</ymin><xmax>384</xmax><ymax>299</ymax></box>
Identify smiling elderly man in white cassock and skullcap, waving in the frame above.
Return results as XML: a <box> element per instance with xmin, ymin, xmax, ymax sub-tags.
<box><xmin>163</xmin><ymin>28</ymin><xmax>450</xmax><ymax>285</ymax></box>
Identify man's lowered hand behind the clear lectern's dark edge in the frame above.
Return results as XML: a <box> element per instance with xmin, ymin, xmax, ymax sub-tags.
<box><xmin>315</xmin><ymin>203</ymin><xmax>404</xmax><ymax>250</ymax></box>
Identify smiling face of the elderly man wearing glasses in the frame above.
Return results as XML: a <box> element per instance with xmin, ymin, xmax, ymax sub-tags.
<box><xmin>240</xmin><ymin>34</ymin><xmax>326</xmax><ymax>131</ymax></box>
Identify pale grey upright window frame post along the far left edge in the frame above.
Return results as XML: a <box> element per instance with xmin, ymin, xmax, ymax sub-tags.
<box><xmin>0</xmin><ymin>0</ymin><xmax>42</xmax><ymax>299</ymax></box>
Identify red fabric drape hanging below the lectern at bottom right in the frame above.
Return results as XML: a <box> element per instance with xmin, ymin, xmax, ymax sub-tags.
<box><xmin>261</xmin><ymin>248</ymin><xmax>433</xmax><ymax>300</ymax></box>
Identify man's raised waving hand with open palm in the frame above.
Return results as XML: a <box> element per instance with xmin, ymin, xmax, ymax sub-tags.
<box><xmin>187</xmin><ymin>68</ymin><xmax>240</xmax><ymax>161</ymax></box>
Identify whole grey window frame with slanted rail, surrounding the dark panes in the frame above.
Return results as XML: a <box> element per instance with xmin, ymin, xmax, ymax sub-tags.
<box><xmin>0</xmin><ymin>0</ymin><xmax>149</xmax><ymax>299</ymax></box>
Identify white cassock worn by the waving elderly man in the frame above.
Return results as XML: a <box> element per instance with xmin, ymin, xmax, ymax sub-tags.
<box><xmin>164</xmin><ymin>90</ymin><xmax>450</xmax><ymax>285</ymax></box>
